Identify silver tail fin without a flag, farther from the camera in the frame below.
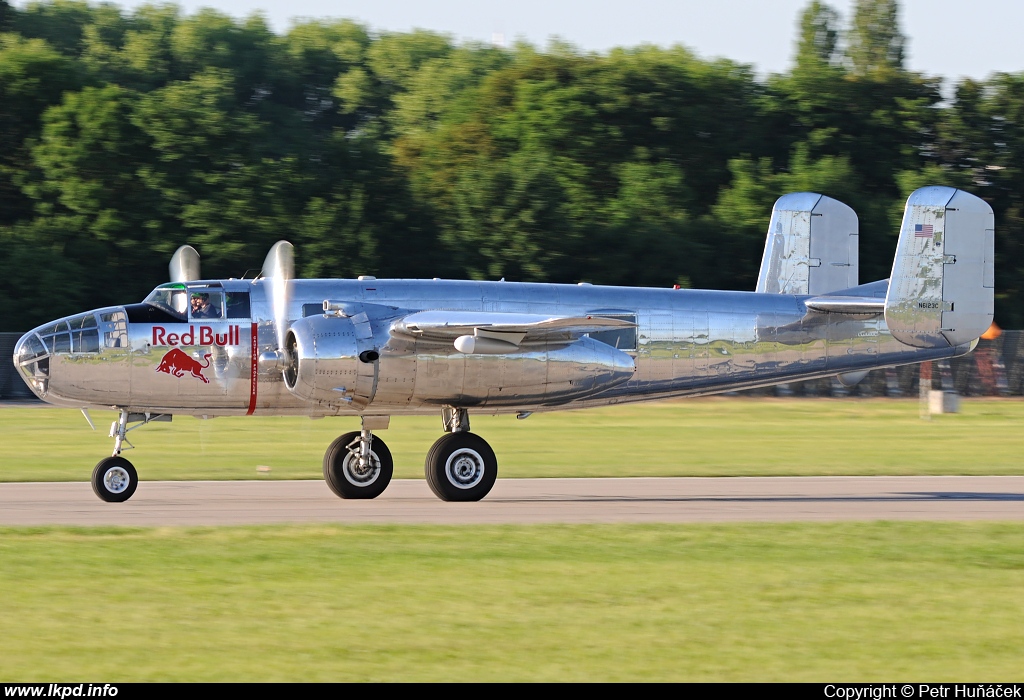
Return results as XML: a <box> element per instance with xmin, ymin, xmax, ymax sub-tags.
<box><xmin>755</xmin><ymin>192</ymin><xmax>859</xmax><ymax>295</ymax></box>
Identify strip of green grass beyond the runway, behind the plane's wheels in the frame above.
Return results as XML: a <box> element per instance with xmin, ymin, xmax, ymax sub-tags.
<box><xmin>0</xmin><ymin>398</ymin><xmax>1024</xmax><ymax>481</ymax></box>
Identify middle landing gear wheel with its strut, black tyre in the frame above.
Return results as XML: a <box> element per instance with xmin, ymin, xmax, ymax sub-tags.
<box><xmin>324</xmin><ymin>415</ymin><xmax>394</xmax><ymax>498</ymax></box>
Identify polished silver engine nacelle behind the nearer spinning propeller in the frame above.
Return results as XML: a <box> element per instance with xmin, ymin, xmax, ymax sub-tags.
<box><xmin>284</xmin><ymin>314</ymin><xmax>636</xmax><ymax>409</ymax></box>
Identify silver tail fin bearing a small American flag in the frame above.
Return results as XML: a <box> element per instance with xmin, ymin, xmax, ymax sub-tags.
<box><xmin>886</xmin><ymin>187</ymin><xmax>995</xmax><ymax>348</ymax></box>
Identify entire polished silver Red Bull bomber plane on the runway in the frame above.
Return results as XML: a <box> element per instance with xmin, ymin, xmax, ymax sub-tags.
<box><xmin>14</xmin><ymin>187</ymin><xmax>994</xmax><ymax>501</ymax></box>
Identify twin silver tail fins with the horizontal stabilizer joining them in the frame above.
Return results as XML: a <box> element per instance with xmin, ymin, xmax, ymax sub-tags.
<box><xmin>756</xmin><ymin>187</ymin><xmax>995</xmax><ymax>348</ymax></box>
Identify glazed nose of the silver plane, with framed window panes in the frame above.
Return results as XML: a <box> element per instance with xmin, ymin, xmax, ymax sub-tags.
<box><xmin>14</xmin><ymin>308</ymin><xmax>128</xmax><ymax>401</ymax></box>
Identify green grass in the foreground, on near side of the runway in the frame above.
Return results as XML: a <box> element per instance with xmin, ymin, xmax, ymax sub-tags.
<box><xmin>0</xmin><ymin>523</ymin><xmax>1024</xmax><ymax>683</ymax></box>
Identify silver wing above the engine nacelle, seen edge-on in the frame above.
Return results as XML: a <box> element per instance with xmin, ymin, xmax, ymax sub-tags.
<box><xmin>391</xmin><ymin>310</ymin><xmax>636</xmax><ymax>353</ymax></box>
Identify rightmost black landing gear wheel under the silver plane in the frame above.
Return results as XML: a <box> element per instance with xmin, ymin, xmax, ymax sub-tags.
<box><xmin>424</xmin><ymin>432</ymin><xmax>498</xmax><ymax>500</ymax></box>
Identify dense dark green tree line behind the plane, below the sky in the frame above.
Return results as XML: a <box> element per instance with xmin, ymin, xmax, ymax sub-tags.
<box><xmin>0</xmin><ymin>0</ymin><xmax>1024</xmax><ymax>331</ymax></box>
